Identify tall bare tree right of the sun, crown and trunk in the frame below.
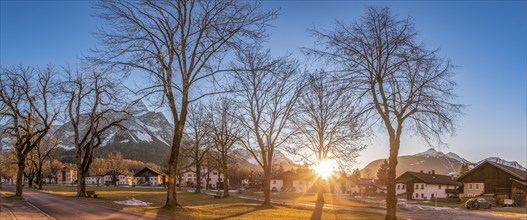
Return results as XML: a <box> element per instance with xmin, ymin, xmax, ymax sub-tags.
<box><xmin>306</xmin><ymin>7</ymin><xmax>463</xmax><ymax>219</ymax></box>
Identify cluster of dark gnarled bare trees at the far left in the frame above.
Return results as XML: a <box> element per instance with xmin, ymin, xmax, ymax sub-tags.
<box><xmin>0</xmin><ymin>62</ymin><xmax>131</xmax><ymax>196</ymax></box>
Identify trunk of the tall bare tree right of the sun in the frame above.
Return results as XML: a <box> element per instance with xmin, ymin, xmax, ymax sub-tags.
<box><xmin>385</xmin><ymin>135</ymin><xmax>401</xmax><ymax>220</ymax></box>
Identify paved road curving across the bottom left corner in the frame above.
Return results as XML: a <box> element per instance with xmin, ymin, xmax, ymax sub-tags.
<box><xmin>3</xmin><ymin>186</ymin><xmax>169</xmax><ymax>220</ymax></box>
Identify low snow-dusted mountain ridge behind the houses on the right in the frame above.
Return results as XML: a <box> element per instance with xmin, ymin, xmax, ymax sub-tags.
<box><xmin>361</xmin><ymin>148</ymin><xmax>527</xmax><ymax>178</ymax></box>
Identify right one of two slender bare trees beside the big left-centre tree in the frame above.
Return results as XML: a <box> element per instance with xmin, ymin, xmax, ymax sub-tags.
<box><xmin>208</xmin><ymin>97</ymin><xmax>241</xmax><ymax>198</ymax></box>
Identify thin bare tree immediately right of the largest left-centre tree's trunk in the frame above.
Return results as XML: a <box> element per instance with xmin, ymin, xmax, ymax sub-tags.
<box><xmin>187</xmin><ymin>103</ymin><xmax>213</xmax><ymax>193</ymax></box>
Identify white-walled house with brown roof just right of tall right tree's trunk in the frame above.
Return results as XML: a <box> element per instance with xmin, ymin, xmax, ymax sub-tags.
<box><xmin>395</xmin><ymin>170</ymin><xmax>463</xmax><ymax>200</ymax></box>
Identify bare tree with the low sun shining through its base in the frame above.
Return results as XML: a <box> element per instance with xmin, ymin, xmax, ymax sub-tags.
<box><xmin>289</xmin><ymin>71</ymin><xmax>364</xmax><ymax>203</ymax></box>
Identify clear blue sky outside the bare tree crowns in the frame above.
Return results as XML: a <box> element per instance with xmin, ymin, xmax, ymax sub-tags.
<box><xmin>0</xmin><ymin>1</ymin><xmax>527</xmax><ymax>167</ymax></box>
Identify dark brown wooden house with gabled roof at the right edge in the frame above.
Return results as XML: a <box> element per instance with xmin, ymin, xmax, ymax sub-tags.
<box><xmin>459</xmin><ymin>161</ymin><xmax>527</xmax><ymax>206</ymax></box>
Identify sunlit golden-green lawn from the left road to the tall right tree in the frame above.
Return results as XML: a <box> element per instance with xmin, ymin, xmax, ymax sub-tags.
<box><xmin>38</xmin><ymin>186</ymin><xmax>384</xmax><ymax>219</ymax></box>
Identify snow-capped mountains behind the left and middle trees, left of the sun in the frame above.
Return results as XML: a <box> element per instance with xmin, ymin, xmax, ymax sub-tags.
<box><xmin>53</xmin><ymin>101</ymin><xmax>296</xmax><ymax>170</ymax></box>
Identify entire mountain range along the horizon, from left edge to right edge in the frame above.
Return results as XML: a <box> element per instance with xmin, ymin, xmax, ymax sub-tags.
<box><xmin>0</xmin><ymin>101</ymin><xmax>526</xmax><ymax>175</ymax></box>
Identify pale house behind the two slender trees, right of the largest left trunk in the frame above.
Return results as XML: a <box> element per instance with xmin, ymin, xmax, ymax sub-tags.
<box><xmin>179</xmin><ymin>167</ymin><xmax>223</xmax><ymax>189</ymax></box>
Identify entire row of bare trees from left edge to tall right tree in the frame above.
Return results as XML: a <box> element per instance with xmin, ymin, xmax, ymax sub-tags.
<box><xmin>0</xmin><ymin>0</ymin><xmax>463</xmax><ymax>219</ymax></box>
